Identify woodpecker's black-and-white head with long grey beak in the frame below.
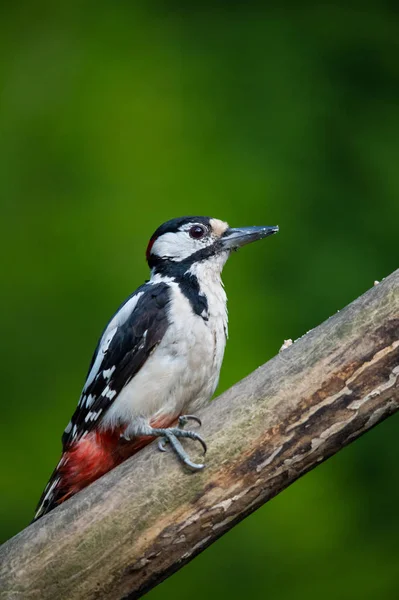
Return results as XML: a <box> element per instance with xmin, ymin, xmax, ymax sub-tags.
<box><xmin>146</xmin><ymin>217</ymin><xmax>278</xmax><ymax>274</ymax></box>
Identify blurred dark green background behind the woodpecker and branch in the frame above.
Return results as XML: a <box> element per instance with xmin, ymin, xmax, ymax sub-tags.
<box><xmin>0</xmin><ymin>0</ymin><xmax>399</xmax><ymax>600</ymax></box>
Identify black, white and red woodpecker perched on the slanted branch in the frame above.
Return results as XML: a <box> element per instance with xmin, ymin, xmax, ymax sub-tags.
<box><xmin>34</xmin><ymin>217</ymin><xmax>278</xmax><ymax>520</ymax></box>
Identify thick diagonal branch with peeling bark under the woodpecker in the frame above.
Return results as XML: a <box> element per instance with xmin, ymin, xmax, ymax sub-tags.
<box><xmin>0</xmin><ymin>270</ymin><xmax>399</xmax><ymax>600</ymax></box>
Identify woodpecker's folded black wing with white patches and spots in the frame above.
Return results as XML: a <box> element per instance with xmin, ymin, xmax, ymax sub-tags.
<box><xmin>62</xmin><ymin>283</ymin><xmax>170</xmax><ymax>450</ymax></box>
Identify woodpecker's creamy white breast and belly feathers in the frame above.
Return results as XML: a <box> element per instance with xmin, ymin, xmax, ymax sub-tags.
<box><xmin>102</xmin><ymin>277</ymin><xmax>227</xmax><ymax>427</ymax></box>
